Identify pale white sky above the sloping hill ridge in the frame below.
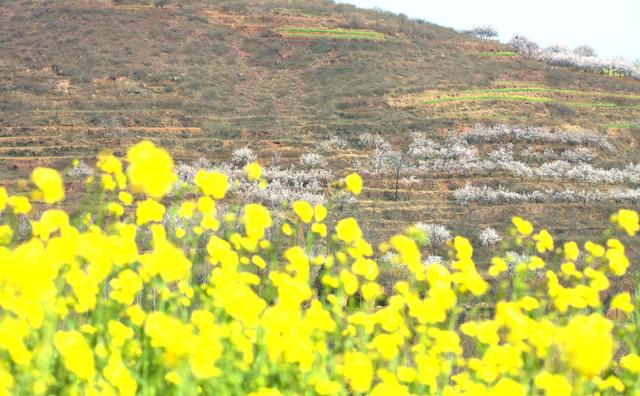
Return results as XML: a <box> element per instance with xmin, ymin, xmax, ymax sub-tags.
<box><xmin>337</xmin><ymin>0</ymin><xmax>640</xmax><ymax>60</ymax></box>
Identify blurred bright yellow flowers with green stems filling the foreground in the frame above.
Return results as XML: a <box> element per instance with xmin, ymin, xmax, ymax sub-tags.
<box><xmin>0</xmin><ymin>142</ymin><xmax>640</xmax><ymax>396</ymax></box>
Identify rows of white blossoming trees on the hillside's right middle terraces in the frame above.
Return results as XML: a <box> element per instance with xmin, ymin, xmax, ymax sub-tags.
<box><xmin>350</xmin><ymin>125</ymin><xmax>640</xmax><ymax>204</ymax></box>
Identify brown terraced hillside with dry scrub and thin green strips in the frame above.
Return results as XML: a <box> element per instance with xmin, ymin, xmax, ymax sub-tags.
<box><xmin>0</xmin><ymin>0</ymin><xmax>640</xmax><ymax>260</ymax></box>
